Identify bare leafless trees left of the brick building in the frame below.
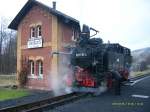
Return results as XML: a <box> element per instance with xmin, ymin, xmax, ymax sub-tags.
<box><xmin>0</xmin><ymin>18</ymin><xmax>17</xmax><ymax>74</ymax></box>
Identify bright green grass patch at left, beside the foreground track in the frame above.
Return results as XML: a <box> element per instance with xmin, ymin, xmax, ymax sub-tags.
<box><xmin>0</xmin><ymin>88</ymin><xmax>29</xmax><ymax>101</ymax></box>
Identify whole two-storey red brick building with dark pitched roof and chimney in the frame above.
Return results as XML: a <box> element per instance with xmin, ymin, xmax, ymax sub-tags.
<box><xmin>9</xmin><ymin>0</ymin><xmax>80</xmax><ymax>89</ymax></box>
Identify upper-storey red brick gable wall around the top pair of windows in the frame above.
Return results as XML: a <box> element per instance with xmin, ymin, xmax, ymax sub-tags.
<box><xmin>20</xmin><ymin>5</ymin><xmax>52</xmax><ymax>48</ymax></box>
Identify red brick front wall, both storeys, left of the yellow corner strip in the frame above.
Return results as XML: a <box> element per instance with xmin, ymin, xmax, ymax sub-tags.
<box><xmin>19</xmin><ymin>6</ymin><xmax>52</xmax><ymax>89</ymax></box>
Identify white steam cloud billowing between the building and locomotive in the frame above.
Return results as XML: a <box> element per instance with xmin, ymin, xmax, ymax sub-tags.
<box><xmin>49</xmin><ymin>54</ymin><xmax>73</xmax><ymax>96</ymax></box>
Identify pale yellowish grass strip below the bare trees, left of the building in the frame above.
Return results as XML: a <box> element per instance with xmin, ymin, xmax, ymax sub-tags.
<box><xmin>0</xmin><ymin>75</ymin><xmax>16</xmax><ymax>85</ymax></box>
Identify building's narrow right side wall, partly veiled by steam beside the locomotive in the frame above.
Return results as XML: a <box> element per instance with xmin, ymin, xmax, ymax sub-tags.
<box><xmin>57</xmin><ymin>22</ymin><xmax>73</xmax><ymax>83</ymax></box>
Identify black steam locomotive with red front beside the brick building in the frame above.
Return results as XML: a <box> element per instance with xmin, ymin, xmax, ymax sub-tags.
<box><xmin>70</xmin><ymin>25</ymin><xmax>131</xmax><ymax>94</ymax></box>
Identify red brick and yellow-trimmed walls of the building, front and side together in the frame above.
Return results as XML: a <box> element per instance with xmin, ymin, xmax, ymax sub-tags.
<box><xmin>17</xmin><ymin>6</ymin><xmax>77</xmax><ymax>90</ymax></box>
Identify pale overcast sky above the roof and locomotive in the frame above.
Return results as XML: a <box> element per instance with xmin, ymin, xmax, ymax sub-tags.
<box><xmin>0</xmin><ymin>0</ymin><xmax>150</xmax><ymax>50</ymax></box>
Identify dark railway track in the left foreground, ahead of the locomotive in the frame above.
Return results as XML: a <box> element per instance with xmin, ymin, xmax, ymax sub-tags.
<box><xmin>0</xmin><ymin>93</ymin><xmax>86</xmax><ymax>112</ymax></box>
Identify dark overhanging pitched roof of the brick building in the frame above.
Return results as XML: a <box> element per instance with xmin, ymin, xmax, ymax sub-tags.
<box><xmin>8</xmin><ymin>0</ymin><xmax>80</xmax><ymax>31</ymax></box>
